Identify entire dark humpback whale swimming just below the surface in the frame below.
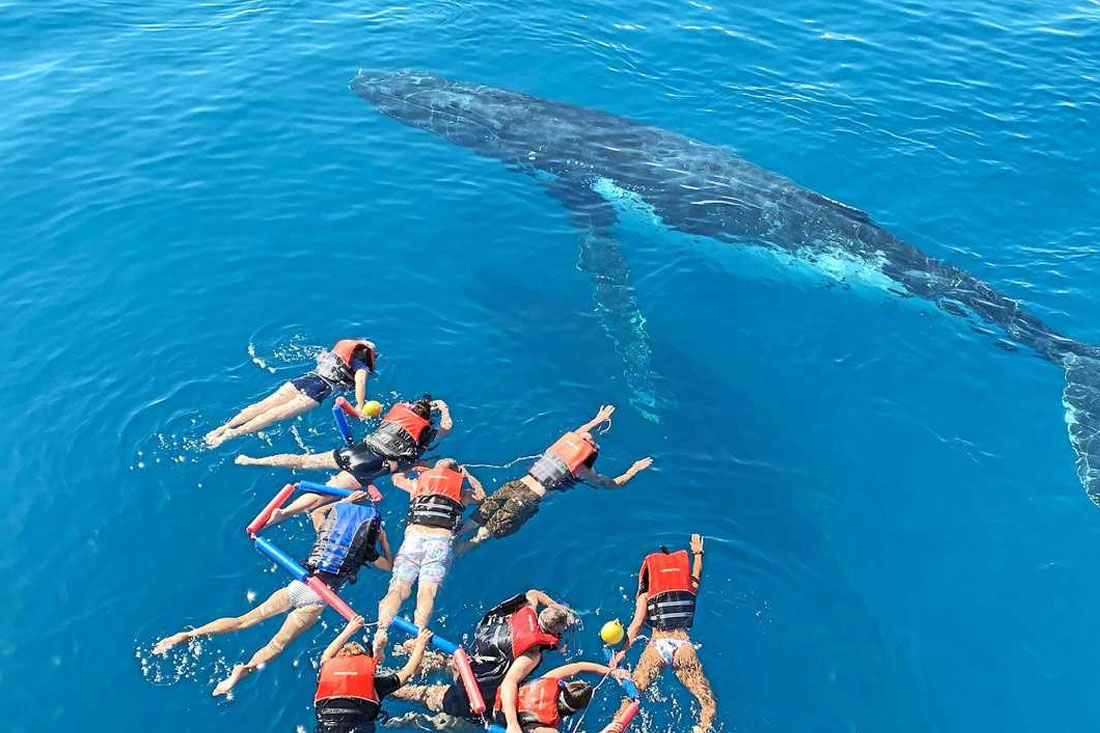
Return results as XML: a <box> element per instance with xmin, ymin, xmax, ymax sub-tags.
<box><xmin>350</xmin><ymin>70</ymin><xmax>1100</xmax><ymax>505</ymax></box>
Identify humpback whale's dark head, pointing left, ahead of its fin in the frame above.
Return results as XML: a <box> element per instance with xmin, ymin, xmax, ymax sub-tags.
<box><xmin>350</xmin><ymin>70</ymin><xmax>583</xmax><ymax>160</ymax></box>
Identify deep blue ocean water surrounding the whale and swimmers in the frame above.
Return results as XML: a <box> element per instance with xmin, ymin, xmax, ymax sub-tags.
<box><xmin>0</xmin><ymin>0</ymin><xmax>1100</xmax><ymax>733</ymax></box>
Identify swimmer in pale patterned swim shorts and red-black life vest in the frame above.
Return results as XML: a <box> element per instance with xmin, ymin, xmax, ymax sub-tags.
<box><xmin>374</xmin><ymin>458</ymin><xmax>485</xmax><ymax>659</ymax></box>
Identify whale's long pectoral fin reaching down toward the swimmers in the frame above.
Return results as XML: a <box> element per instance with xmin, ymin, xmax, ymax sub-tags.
<box><xmin>541</xmin><ymin>173</ymin><xmax>658</xmax><ymax>422</ymax></box>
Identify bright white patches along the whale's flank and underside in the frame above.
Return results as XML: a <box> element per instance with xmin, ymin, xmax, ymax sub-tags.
<box><xmin>592</xmin><ymin>176</ymin><xmax>898</xmax><ymax>291</ymax></box>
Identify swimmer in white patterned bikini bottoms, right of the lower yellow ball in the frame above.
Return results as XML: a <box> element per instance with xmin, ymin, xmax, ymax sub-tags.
<box><xmin>615</xmin><ymin>535</ymin><xmax>718</xmax><ymax>733</ymax></box>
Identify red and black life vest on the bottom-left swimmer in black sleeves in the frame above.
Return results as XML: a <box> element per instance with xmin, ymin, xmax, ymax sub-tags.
<box><xmin>314</xmin><ymin>654</ymin><xmax>381</xmax><ymax>733</ymax></box>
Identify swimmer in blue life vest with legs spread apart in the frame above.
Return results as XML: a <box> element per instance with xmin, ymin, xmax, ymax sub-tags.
<box><xmin>153</xmin><ymin>491</ymin><xmax>393</xmax><ymax>696</ymax></box>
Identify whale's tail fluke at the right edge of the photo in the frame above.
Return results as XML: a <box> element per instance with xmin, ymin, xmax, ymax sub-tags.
<box><xmin>1062</xmin><ymin>353</ymin><xmax>1100</xmax><ymax>505</ymax></box>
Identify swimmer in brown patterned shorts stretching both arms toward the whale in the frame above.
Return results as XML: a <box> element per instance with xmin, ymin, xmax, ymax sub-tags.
<box><xmin>457</xmin><ymin>405</ymin><xmax>653</xmax><ymax>553</ymax></box>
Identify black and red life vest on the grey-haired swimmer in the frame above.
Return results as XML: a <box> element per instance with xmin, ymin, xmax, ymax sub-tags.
<box><xmin>470</xmin><ymin>593</ymin><xmax>561</xmax><ymax>685</ymax></box>
